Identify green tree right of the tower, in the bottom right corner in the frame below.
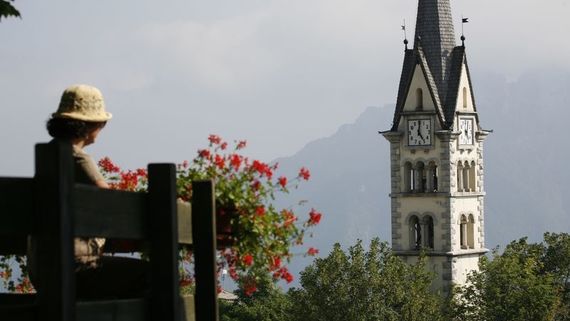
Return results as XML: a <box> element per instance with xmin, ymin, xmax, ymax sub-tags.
<box><xmin>451</xmin><ymin>233</ymin><xmax>570</xmax><ymax>321</ymax></box>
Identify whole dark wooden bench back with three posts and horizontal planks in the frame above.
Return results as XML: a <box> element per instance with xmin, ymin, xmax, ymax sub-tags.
<box><xmin>0</xmin><ymin>142</ymin><xmax>218</xmax><ymax>321</ymax></box>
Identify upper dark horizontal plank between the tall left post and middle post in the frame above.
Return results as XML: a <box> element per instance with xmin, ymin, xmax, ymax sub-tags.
<box><xmin>72</xmin><ymin>184</ymin><xmax>148</xmax><ymax>240</ymax></box>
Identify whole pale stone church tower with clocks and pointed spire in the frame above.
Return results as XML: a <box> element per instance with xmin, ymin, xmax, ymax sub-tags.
<box><xmin>382</xmin><ymin>0</ymin><xmax>490</xmax><ymax>294</ymax></box>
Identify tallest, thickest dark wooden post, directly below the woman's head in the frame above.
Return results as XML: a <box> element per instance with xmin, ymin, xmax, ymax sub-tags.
<box><xmin>34</xmin><ymin>141</ymin><xmax>75</xmax><ymax>321</ymax></box>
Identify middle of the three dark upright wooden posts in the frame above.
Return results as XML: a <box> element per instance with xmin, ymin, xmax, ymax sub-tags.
<box><xmin>148</xmin><ymin>164</ymin><xmax>180</xmax><ymax>321</ymax></box>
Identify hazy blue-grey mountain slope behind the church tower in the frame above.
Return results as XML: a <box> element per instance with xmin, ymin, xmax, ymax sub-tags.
<box><xmin>277</xmin><ymin>72</ymin><xmax>570</xmax><ymax>282</ymax></box>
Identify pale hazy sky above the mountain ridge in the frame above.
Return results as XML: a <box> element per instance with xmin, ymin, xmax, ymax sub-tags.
<box><xmin>0</xmin><ymin>0</ymin><xmax>570</xmax><ymax>175</ymax></box>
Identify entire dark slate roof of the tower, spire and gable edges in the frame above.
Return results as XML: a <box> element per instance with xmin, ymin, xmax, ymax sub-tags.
<box><xmin>392</xmin><ymin>0</ymin><xmax>473</xmax><ymax>131</ymax></box>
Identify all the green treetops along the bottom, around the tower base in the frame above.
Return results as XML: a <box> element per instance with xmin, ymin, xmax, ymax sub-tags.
<box><xmin>221</xmin><ymin>233</ymin><xmax>570</xmax><ymax>321</ymax></box>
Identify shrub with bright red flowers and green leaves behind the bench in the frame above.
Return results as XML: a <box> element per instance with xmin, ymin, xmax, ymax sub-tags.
<box><xmin>99</xmin><ymin>135</ymin><xmax>322</xmax><ymax>294</ymax></box>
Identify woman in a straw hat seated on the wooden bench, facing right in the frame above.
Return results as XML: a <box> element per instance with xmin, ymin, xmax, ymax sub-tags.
<box><xmin>28</xmin><ymin>85</ymin><xmax>149</xmax><ymax>299</ymax></box>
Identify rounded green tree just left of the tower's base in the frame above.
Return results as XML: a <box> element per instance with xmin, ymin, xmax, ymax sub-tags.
<box><xmin>289</xmin><ymin>239</ymin><xmax>442</xmax><ymax>321</ymax></box>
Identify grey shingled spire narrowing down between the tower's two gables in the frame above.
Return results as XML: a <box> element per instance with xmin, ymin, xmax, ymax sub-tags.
<box><xmin>414</xmin><ymin>0</ymin><xmax>455</xmax><ymax>97</ymax></box>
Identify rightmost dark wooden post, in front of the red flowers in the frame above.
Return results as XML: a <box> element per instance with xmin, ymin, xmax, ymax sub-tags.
<box><xmin>192</xmin><ymin>181</ymin><xmax>218</xmax><ymax>321</ymax></box>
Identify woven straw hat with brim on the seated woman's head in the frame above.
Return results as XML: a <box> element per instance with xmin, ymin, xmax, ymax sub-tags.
<box><xmin>52</xmin><ymin>85</ymin><xmax>113</xmax><ymax>122</ymax></box>
